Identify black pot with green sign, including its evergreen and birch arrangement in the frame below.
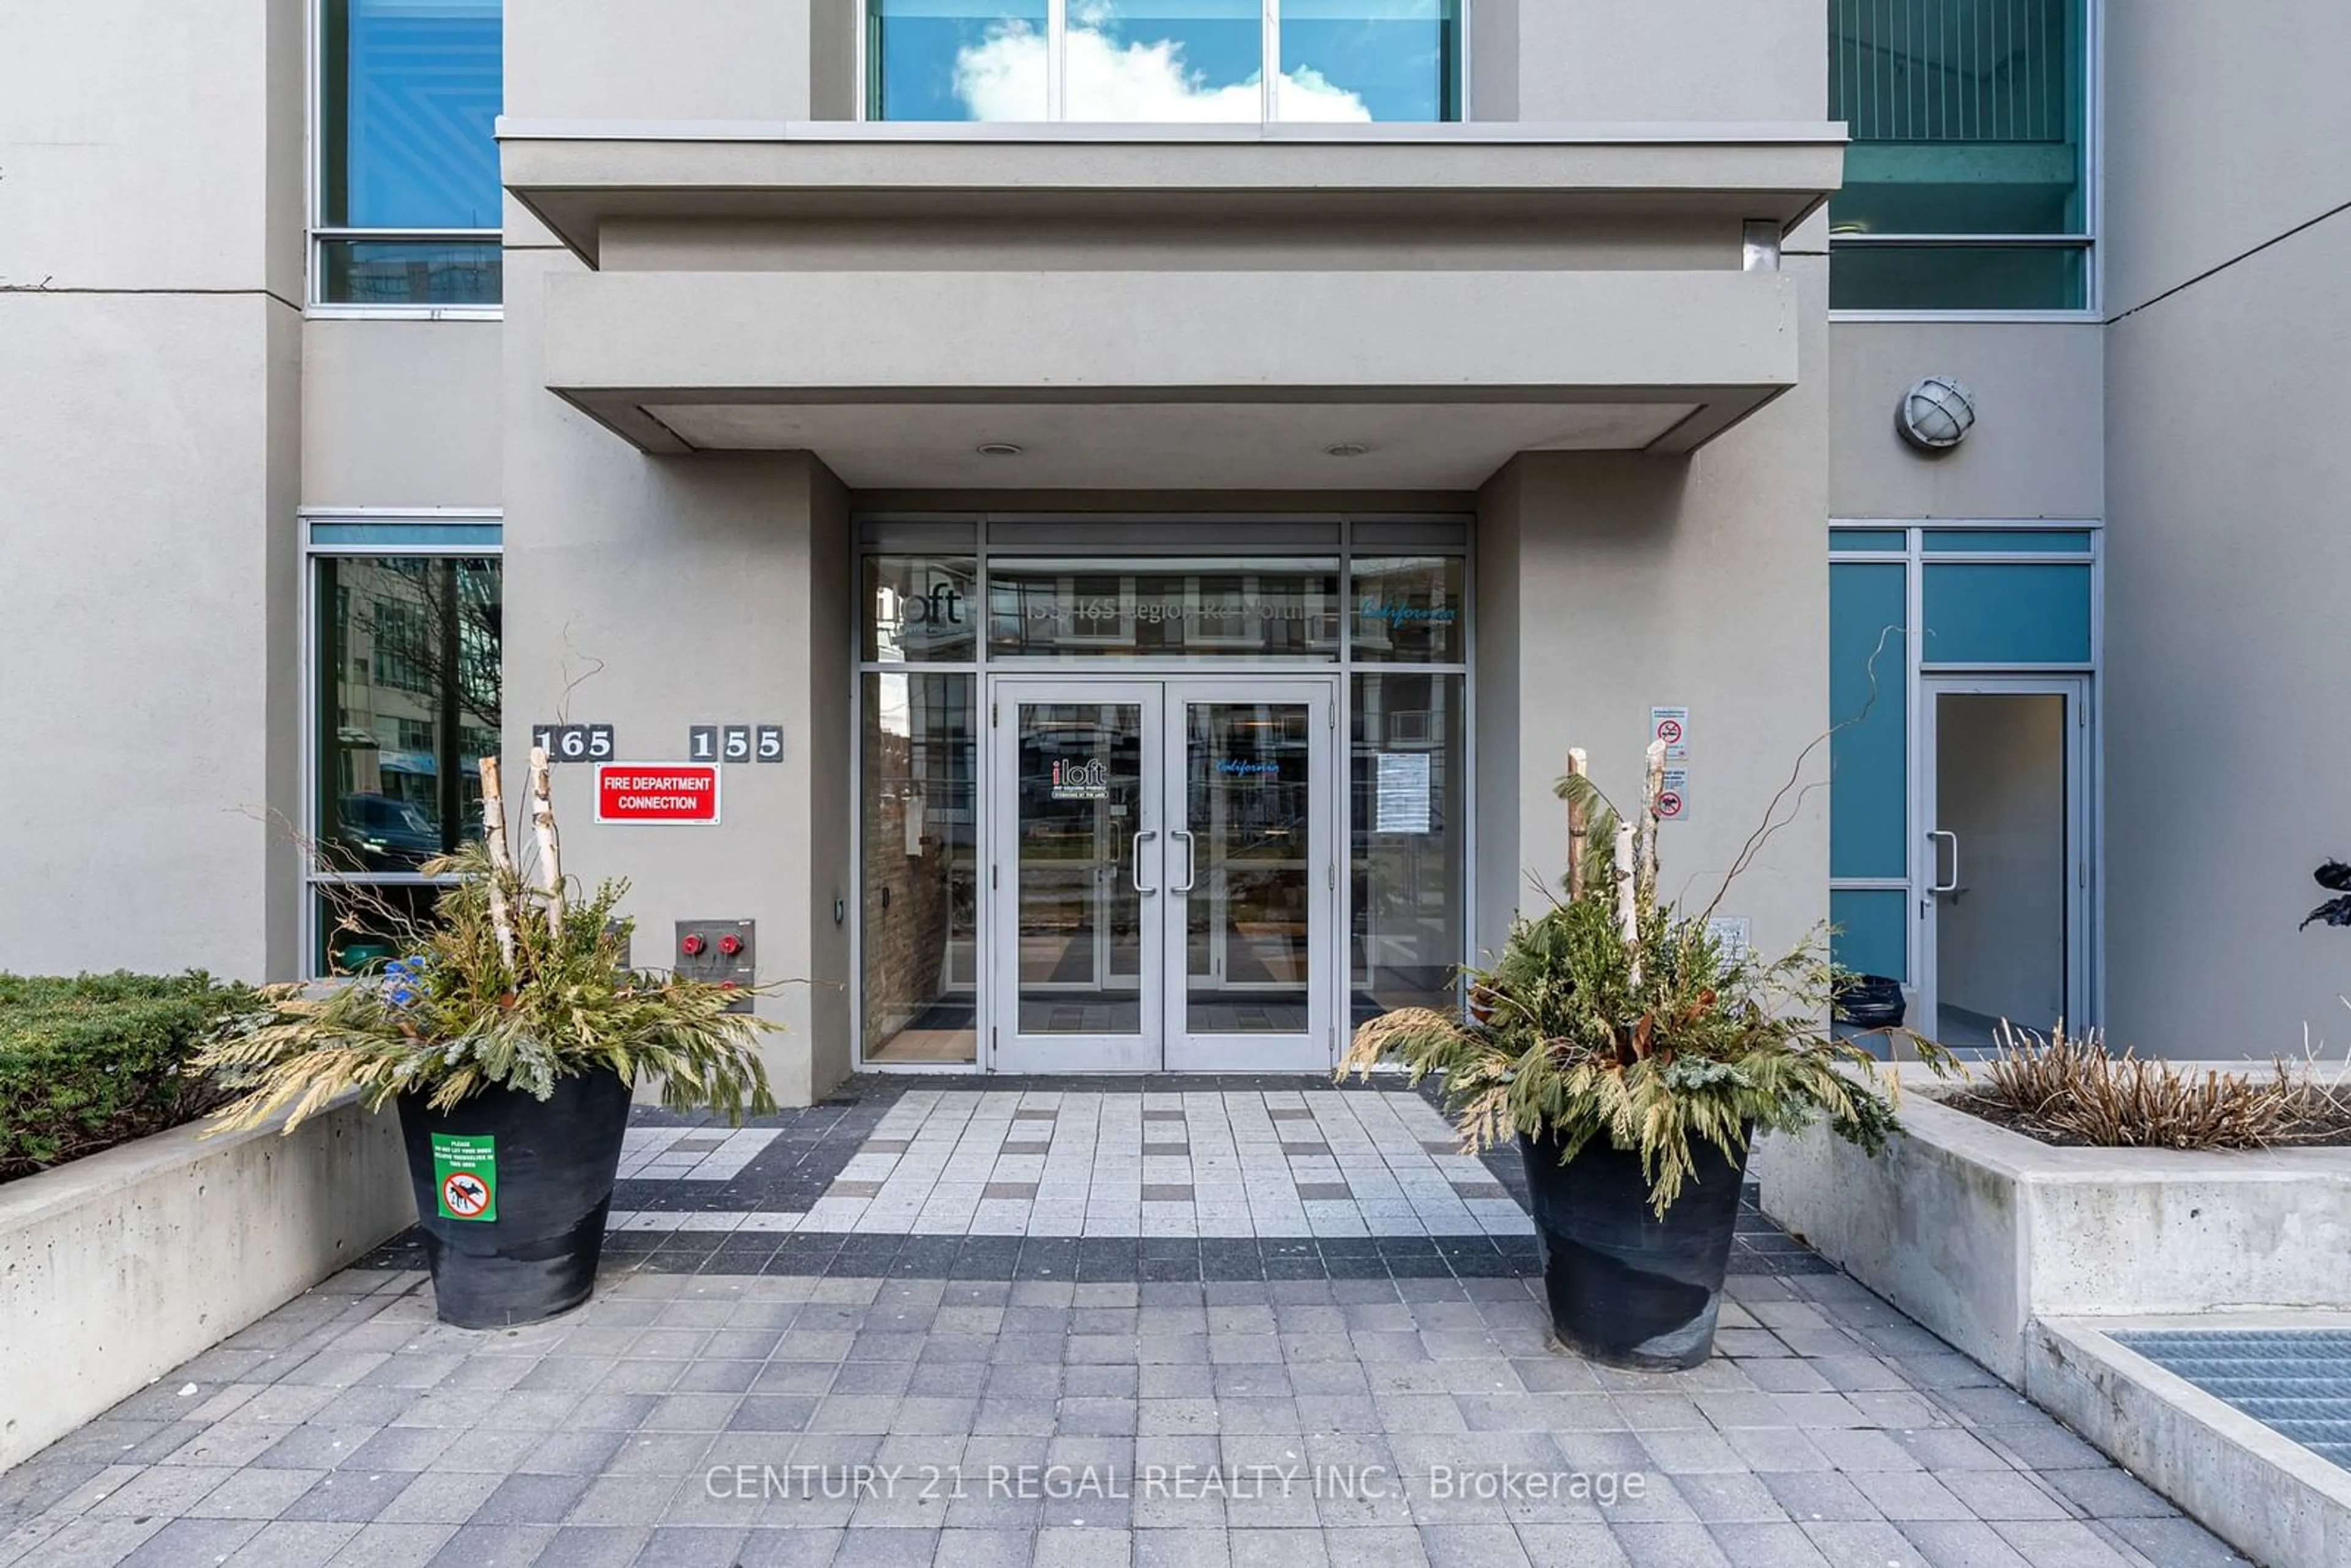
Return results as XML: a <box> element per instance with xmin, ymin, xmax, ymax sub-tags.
<box><xmin>202</xmin><ymin>750</ymin><xmax>776</xmax><ymax>1328</ymax></box>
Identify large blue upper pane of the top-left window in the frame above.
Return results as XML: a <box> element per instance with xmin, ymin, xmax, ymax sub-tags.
<box><xmin>320</xmin><ymin>0</ymin><xmax>506</xmax><ymax>228</ymax></box>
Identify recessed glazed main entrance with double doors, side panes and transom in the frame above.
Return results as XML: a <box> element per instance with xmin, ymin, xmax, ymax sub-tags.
<box><xmin>839</xmin><ymin>515</ymin><xmax>1472</xmax><ymax>1072</ymax></box>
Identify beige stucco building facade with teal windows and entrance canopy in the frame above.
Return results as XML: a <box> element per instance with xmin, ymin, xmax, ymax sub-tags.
<box><xmin>0</xmin><ymin>0</ymin><xmax>2351</xmax><ymax>1100</ymax></box>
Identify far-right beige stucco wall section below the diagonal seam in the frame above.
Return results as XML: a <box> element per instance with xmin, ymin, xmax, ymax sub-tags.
<box><xmin>2107</xmin><ymin>216</ymin><xmax>2351</xmax><ymax>1056</ymax></box>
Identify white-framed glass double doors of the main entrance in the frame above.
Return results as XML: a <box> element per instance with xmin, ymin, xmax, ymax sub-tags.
<box><xmin>988</xmin><ymin>677</ymin><xmax>1338</xmax><ymax>1072</ymax></box>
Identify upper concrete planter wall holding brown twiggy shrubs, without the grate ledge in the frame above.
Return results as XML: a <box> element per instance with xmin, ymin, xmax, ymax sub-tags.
<box><xmin>1763</xmin><ymin>1072</ymin><xmax>2351</xmax><ymax>1387</ymax></box>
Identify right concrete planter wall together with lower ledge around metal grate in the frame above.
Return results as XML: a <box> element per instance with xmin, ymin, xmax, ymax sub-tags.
<box><xmin>1763</xmin><ymin>1084</ymin><xmax>2351</xmax><ymax>1568</ymax></box>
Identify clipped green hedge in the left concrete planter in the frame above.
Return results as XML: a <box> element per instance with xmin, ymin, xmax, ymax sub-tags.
<box><xmin>0</xmin><ymin>971</ymin><xmax>252</xmax><ymax>1180</ymax></box>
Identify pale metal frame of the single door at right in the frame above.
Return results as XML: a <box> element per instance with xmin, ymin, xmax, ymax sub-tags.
<box><xmin>1911</xmin><ymin>675</ymin><xmax>2097</xmax><ymax>1039</ymax></box>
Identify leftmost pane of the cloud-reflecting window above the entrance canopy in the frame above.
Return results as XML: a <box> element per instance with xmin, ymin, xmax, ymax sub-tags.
<box><xmin>865</xmin><ymin>0</ymin><xmax>1049</xmax><ymax>120</ymax></box>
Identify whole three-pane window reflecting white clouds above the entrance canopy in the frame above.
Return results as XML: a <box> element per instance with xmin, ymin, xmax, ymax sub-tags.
<box><xmin>868</xmin><ymin>0</ymin><xmax>1462</xmax><ymax>124</ymax></box>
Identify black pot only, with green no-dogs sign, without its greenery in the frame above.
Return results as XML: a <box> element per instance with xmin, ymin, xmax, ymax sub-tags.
<box><xmin>400</xmin><ymin>1072</ymin><xmax>630</xmax><ymax>1328</ymax></box>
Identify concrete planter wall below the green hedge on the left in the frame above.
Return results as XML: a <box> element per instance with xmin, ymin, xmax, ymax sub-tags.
<box><xmin>0</xmin><ymin>1100</ymin><xmax>416</xmax><ymax>1469</ymax></box>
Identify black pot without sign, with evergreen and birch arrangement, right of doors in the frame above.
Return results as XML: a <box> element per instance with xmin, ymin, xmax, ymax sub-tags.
<box><xmin>1340</xmin><ymin>745</ymin><xmax>1935</xmax><ymax>1366</ymax></box>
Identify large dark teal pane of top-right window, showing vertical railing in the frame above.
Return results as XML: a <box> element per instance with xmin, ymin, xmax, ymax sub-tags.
<box><xmin>1829</xmin><ymin>0</ymin><xmax>2088</xmax><ymax>235</ymax></box>
